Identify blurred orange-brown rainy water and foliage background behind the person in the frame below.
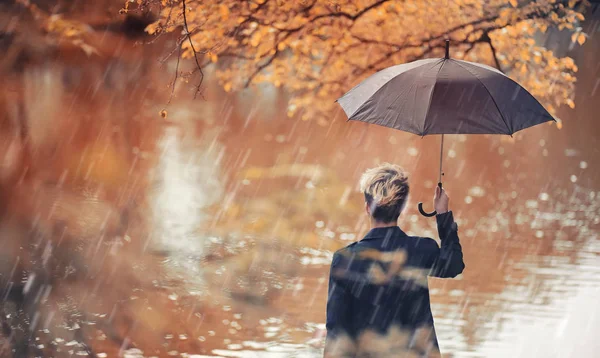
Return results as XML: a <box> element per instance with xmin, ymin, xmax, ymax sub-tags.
<box><xmin>0</xmin><ymin>0</ymin><xmax>600</xmax><ymax>357</ymax></box>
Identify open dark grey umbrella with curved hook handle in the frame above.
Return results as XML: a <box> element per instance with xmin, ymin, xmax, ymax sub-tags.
<box><xmin>337</xmin><ymin>40</ymin><xmax>555</xmax><ymax>216</ymax></box>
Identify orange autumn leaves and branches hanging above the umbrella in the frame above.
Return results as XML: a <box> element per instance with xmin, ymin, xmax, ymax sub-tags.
<box><xmin>139</xmin><ymin>0</ymin><xmax>588</xmax><ymax>124</ymax></box>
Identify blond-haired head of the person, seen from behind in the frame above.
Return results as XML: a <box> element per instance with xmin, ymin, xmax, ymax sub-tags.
<box><xmin>360</xmin><ymin>163</ymin><xmax>409</xmax><ymax>223</ymax></box>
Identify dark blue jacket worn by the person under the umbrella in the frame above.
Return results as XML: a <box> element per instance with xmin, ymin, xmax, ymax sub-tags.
<box><xmin>325</xmin><ymin>212</ymin><xmax>465</xmax><ymax>357</ymax></box>
